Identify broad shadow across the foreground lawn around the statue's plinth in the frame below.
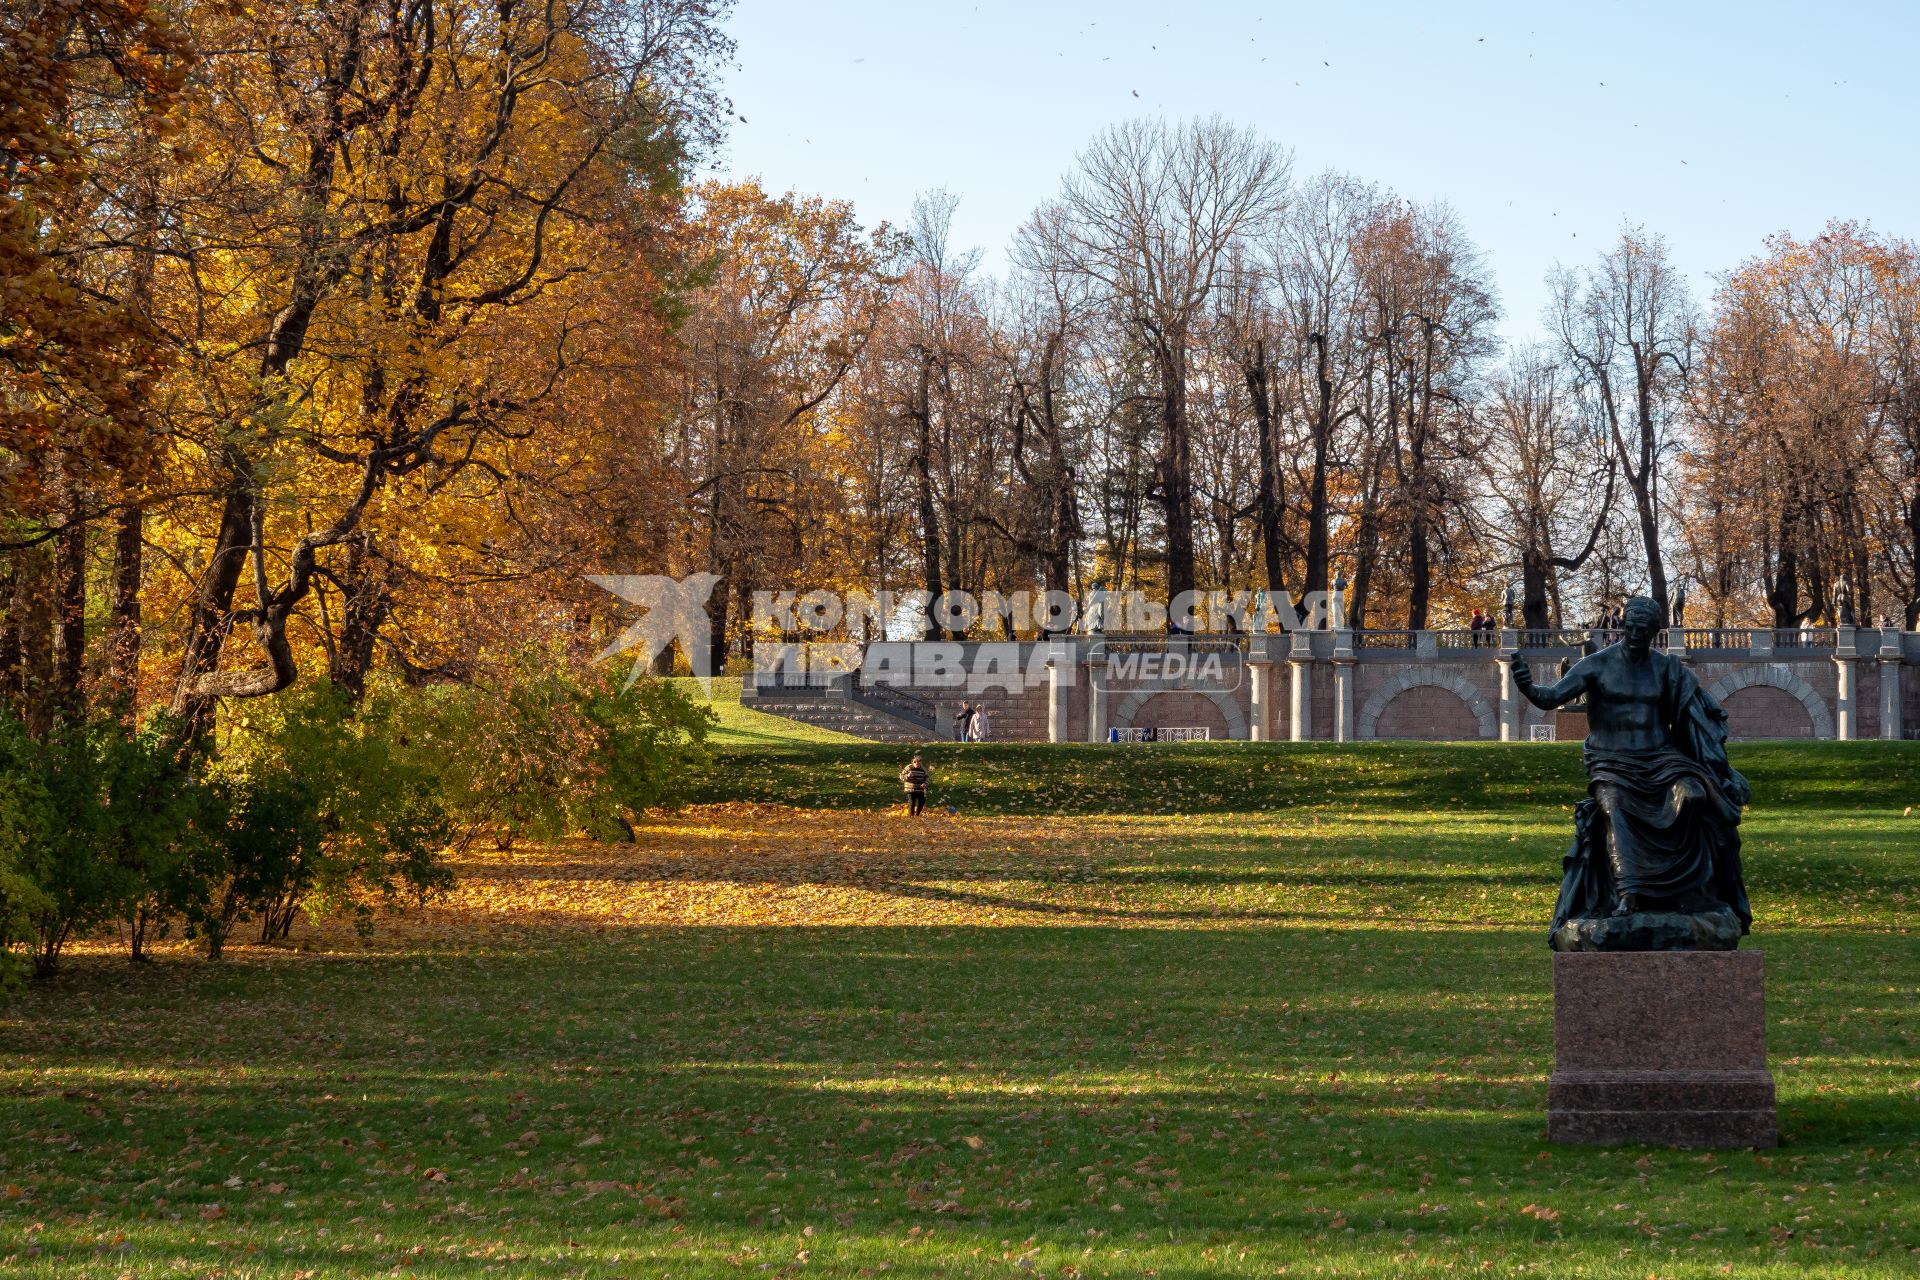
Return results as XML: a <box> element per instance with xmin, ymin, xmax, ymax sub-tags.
<box><xmin>0</xmin><ymin>925</ymin><xmax>1920</xmax><ymax>1274</ymax></box>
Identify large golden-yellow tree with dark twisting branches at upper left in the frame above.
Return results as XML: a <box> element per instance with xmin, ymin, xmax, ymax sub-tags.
<box><xmin>133</xmin><ymin>0</ymin><xmax>726</xmax><ymax>723</ymax></box>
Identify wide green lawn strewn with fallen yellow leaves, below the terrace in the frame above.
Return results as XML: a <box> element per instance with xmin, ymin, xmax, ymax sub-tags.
<box><xmin>0</xmin><ymin>736</ymin><xmax>1920</xmax><ymax>1280</ymax></box>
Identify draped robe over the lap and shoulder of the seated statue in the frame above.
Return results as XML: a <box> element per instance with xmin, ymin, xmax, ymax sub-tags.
<box><xmin>1549</xmin><ymin>652</ymin><xmax>1753</xmax><ymax>935</ymax></box>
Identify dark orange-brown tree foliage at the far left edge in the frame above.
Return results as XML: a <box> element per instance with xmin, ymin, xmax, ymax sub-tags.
<box><xmin>0</xmin><ymin>0</ymin><xmax>192</xmax><ymax>729</ymax></box>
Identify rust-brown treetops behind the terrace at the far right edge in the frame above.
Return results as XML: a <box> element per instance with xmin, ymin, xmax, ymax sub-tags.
<box><xmin>1688</xmin><ymin>223</ymin><xmax>1912</xmax><ymax>628</ymax></box>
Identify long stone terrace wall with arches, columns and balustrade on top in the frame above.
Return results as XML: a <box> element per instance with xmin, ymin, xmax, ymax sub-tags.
<box><xmin>743</xmin><ymin>628</ymin><xmax>1920</xmax><ymax>743</ymax></box>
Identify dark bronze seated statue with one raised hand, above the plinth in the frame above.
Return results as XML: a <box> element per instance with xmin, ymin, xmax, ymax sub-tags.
<box><xmin>1511</xmin><ymin>595</ymin><xmax>1753</xmax><ymax>952</ymax></box>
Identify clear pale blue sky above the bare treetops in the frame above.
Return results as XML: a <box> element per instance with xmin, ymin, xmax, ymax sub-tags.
<box><xmin>720</xmin><ymin>0</ymin><xmax>1920</xmax><ymax>340</ymax></box>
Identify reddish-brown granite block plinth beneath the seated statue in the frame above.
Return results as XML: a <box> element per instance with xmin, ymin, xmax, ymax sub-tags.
<box><xmin>1548</xmin><ymin>952</ymin><xmax>1780</xmax><ymax>1148</ymax></box>
